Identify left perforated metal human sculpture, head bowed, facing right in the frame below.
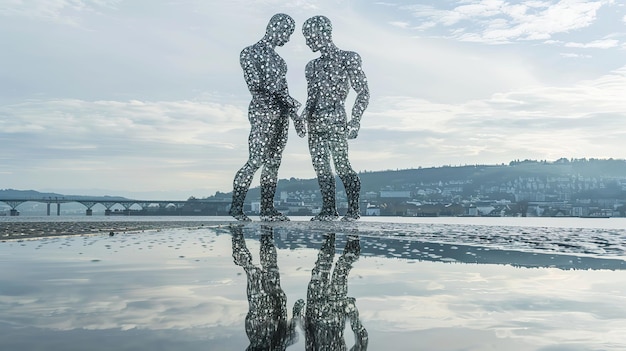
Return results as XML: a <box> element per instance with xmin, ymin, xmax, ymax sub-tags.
<box><xmin>230</xmin><ymin>14</ymin><xmax>304</xmax><ymax>221</ymax></box>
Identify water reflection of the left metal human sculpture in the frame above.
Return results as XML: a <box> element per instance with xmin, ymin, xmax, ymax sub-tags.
<box><xmin>230</xmin><ymin>226</ymin><xmax>298</xmax><ymax>350</ymax></box>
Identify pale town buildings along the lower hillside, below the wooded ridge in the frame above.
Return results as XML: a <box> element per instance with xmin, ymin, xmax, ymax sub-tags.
<box><xmin>260</xmin><ymin>177</ymin><xmax>626</xmax><ymax>217</ymax></box>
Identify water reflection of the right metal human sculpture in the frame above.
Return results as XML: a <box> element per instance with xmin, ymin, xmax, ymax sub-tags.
<box><xmin>294</xmin><ymin>234</ymin><xmax>368</xmax><ymax>351</ymax></box>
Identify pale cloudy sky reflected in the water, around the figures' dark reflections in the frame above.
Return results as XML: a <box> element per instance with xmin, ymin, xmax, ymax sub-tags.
<box><xmin>0</xmin><ymin>223</ymin><xmax>626</xmax><ymax>350</ymax></box>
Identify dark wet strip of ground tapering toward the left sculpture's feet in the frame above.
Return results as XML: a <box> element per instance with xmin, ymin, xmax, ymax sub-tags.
<box><xmin>0</xmin><ymin>221</ymin><xmax>230</xmax><ymax>241</ymax></box>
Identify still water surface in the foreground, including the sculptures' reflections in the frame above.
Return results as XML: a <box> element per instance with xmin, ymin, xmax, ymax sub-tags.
<box><xmin>0</xmin><ymin>217</ymin><xmax>626</xmax><ymax>351</ymax></box>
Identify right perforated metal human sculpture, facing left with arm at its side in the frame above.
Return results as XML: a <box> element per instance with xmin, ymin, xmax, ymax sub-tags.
<box><xmin>302</xmin><ymin>16</ymin><xmax>369</xmax><ymax>221</ymax></box>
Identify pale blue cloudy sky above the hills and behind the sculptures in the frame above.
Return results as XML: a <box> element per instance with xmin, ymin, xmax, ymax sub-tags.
<box><xmin>0</xmin><ymin>0</ymin><xmax>626</xmax><ymax>199</ymax></box>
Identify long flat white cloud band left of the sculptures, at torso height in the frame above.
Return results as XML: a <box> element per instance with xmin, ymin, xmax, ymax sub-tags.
<box><xmin>0</xmin><ymin>99</ymin><xmax>246</xmax><ymax>145</ymax></box>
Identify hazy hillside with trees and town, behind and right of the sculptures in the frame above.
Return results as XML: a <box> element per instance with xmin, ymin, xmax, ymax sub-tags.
<box><xmin>230</xmin><ymin>159</ymin><xmax>626</xmax><ymax>217</ymax></box>
